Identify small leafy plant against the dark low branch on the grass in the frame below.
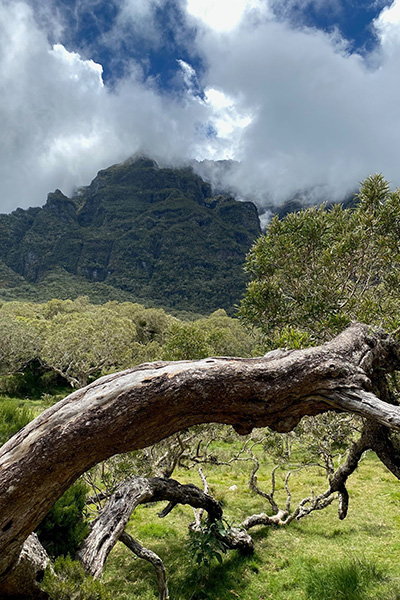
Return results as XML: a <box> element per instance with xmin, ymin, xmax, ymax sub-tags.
<box><xmin>188</xmin><ymin>521</ymin><xmax>229</xmax><ymax>579</ymax></box>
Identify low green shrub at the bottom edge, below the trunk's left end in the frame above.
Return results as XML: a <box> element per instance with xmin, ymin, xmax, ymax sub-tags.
<box><xmin>41</xmin><ymin>556</ymin><xmax>111</xmax><ymax>600</ymax></box>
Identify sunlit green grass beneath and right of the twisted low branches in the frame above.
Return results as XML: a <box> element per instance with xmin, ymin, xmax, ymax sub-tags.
<box><xmin>104</xmin><ymin>453</ymin><xmax>400</xmax><ymax>600</ymax></box>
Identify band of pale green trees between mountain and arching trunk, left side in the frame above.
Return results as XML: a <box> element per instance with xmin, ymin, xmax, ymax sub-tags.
<box><xmin>0</xmin><ymin>296</ymin><xmax>256</xmax><ymax>397</ymax></box>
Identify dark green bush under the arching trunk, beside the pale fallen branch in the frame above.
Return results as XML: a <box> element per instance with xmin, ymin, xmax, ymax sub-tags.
<box><xmin>36</xmin><ymin>481</ymin><xmax>89</xmax><ymax>557</ymax></box>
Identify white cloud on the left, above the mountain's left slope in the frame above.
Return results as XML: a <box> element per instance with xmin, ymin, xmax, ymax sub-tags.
<box><xmin>0</xmin><ymin>2</ymin><xmax>206</xmax><ymax>212</ymax></box>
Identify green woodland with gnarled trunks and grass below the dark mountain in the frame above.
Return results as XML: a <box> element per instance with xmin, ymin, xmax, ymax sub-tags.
<box><xmin>0</xmin><ymin>175</ymin><xmax>400</xmax><ymax>600</ymax></box>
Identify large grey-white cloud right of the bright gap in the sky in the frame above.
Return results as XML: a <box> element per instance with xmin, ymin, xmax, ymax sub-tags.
<box><xmin>185</xmin><ymin>2</ymin><xmax>400</xmax><ymax>205</ymax></box>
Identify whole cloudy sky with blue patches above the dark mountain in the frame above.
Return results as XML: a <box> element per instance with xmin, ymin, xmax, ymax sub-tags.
<box><xmin>0</xmin><ymin>0</ymin><xmax>400</xmax><ymax>213</ymax></box>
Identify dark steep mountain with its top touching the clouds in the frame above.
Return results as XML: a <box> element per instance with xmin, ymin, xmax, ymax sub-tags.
<box><xmin>0</xmin><ymin>158</ymin><xmax>260</xmax><ymax>312</ymax></box>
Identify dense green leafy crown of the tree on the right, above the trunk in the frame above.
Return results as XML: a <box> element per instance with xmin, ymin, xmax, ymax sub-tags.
<box><xmin>240</xmin><ymin>175</ymin><xmax>400</xmax><ymax>348</ymax></box>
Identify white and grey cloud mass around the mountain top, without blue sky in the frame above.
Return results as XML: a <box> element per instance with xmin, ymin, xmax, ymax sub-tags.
<box><xmin>0</xmin><ymin>0</ymin><xmax>400</xmax><ymax>212</ymax></box>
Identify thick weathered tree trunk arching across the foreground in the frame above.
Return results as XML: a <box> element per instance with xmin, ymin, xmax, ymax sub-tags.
<box><xmin>0</xmin><ymin>325</ymin><xmax>400</xmax><ymax>592</ymax></box>
